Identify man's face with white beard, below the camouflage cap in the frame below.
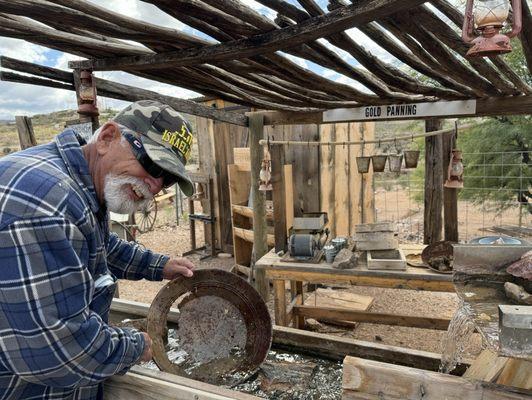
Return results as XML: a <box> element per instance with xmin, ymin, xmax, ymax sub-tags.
<box><xmin>94</xmin><ymin>122</ymin><xmax>162</xmax><ymax>214</ymax></box>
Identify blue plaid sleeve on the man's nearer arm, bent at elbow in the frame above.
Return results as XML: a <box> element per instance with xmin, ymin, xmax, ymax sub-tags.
<box><xmin>0</xmin><ymin>217</ymin><xmax>144</xmax><ymax>388</ymax></box>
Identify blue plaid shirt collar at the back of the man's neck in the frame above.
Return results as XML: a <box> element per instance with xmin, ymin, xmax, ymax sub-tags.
<box><xmin>55</xmin><ymin>129</ymin><xmax>106</xmax><ymax>215</ymax></box>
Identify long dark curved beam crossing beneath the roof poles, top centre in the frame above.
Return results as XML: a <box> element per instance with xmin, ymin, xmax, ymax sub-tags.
<box><xmin>69</xmin><ymin>0</ymin><xmax>423</xmax><ymax>71</ymax></box>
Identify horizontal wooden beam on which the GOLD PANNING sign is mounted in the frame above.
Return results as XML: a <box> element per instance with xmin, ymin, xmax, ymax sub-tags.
<box><xmin>252</xmin><ymin>96</ymin><xmax>532</xmax><ymax>125</ymax></box>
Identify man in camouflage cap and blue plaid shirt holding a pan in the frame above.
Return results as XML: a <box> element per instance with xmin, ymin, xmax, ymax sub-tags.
<box><xmin>0</xmin><ymin>100</ymin><xmax>194</xmax><ymax>400</ymax></box>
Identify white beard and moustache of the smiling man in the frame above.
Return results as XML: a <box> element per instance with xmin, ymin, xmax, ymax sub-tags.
<box><xmin>103</xmin><ymin>174</ymin><xmax>153</xmax><ymax>214</ymax></box>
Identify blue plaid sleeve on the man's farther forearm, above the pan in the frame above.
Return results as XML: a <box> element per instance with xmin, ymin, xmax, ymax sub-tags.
<box><xmin>107</xmin><ymin>233</ymin><xmax>168</xmax><ymax>281</ymax></box>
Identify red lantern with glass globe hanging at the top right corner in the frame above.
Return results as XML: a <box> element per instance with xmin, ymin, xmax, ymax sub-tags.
<box><xmin>462</xmin><ymin>0</ymin><xmax>522</xmax><ymax>57</ymax></box>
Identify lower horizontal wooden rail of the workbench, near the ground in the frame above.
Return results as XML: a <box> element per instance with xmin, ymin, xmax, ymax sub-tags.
<box><xmin>294</xmin><ymin>305</ymin><xmax>450</xmax><ymax>331</ymax></box>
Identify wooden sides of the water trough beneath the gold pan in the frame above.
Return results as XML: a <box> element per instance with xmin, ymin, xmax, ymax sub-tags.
<box><xmin>105</xmin><ymin>299</ymin><xmax>469</xmax><ymax>400</ymax></box>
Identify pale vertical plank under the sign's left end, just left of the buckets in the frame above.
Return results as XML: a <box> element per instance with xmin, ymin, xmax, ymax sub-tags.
<box><xmin>329</xmin><ymin>123</ymin><xmax>350</xmax><ymax>236</ymax></box>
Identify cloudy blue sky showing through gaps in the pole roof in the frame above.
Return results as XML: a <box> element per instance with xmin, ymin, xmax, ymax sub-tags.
<box><xmin>0</xmin><ymin>0</ymin><xmax>428</xmax><ymax>120</ymax></box>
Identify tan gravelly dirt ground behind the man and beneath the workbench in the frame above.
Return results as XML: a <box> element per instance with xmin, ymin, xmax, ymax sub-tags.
<box><xmin>119</xmin><ymin>205</ymin><xmax>482</xmax><ymax>358</ymax></box>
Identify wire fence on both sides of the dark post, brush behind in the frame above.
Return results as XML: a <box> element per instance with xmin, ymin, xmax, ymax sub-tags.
<box><xmin>374</xmin><ymin>151</ymin><xmax>532</xmax><ymax>243</ymax></box>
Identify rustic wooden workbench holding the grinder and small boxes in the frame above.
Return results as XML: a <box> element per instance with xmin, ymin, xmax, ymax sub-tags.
<box><xmin>255</xmin><ymin>250</ymin><xmax>454</xmax><ymax>330</ymax></box>
